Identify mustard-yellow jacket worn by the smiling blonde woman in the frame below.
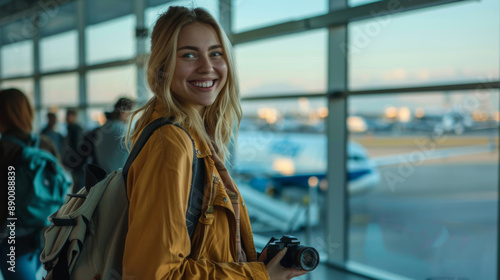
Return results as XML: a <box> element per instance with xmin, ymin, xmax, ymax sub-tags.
<box><xmin>123</xmin><ymin>111</ymin><xmax>269</xmax><ymax>280</ymax></box>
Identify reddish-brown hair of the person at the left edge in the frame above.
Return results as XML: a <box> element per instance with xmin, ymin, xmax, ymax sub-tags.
<box><xmin>0</xmin><ymin>88</ymin><xmax>34</xmax><ymax>133</ymax></box>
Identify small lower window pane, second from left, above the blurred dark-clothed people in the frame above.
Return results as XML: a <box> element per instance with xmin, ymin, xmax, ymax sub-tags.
<box><xmin>40</xmin><ymin>73</ymin><xmax>79</xmax><ymax>107</ymax></box>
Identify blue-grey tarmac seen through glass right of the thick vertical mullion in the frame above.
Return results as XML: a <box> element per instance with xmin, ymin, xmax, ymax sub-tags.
<box><xmin>349</xmin><ymin>163</ymin><xmax>498</xmax><ymax>280</ymax></box>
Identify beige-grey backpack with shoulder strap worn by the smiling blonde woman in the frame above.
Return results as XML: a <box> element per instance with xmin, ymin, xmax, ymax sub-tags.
<box><xmin>40</xmin><ymin>118</ymin><xmax>205</xmax><ymax>280</ymax></box>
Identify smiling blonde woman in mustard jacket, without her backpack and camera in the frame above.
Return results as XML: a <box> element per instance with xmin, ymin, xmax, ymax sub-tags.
<box><xmin>123</xmin><ymin>7</ymin><xmax>306</xmax><ymax>280</ymax></box>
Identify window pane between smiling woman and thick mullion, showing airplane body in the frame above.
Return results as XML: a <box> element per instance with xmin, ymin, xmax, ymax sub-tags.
<box><xmin>231</xmin><ymin>98</ymin><xmax>329</xmax><ymax>279</ymax></box>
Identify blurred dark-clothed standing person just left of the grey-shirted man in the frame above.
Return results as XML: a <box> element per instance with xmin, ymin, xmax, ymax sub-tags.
<box><xmin>63</xmin><ymin>109</ymin><xmax>85</xmax><ymax>193</ymax></box>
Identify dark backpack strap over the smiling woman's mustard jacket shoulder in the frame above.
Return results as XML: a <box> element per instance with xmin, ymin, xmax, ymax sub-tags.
<box><xmin>122</xmin><ymin>118</ymin><xmax>201</xmax><ymax>238</ymax></box>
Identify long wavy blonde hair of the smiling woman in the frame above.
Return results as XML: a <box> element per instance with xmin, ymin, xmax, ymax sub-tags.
<box><xmin>126</xmin><ymin>6</ymin><xmax>242</xmax><ymax>160</ymax></box>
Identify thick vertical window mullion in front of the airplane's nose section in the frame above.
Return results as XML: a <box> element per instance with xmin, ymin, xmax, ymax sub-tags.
<box><xmin>324</xmin><ymin>0</ymin><xmax>348</xmax><ymax>266</ymax></box>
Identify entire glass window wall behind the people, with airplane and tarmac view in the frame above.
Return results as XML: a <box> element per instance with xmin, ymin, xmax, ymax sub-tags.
<box><xmin>0</xmin><ymin>0</ymin><xmax>500</xmax><ymax>280</ymax></box>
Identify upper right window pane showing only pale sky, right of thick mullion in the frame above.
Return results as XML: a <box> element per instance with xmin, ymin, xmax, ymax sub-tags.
<box><xmin>350</xmin><ymin>0</ymin><xmax>500</xmax><ymax>89</ymax></box>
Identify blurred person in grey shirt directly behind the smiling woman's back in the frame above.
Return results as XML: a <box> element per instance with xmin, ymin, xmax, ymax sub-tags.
<box><xmin>79</xmin><ymin>97</ymin><xmax>135</xmax><ymax>174</ymax></box>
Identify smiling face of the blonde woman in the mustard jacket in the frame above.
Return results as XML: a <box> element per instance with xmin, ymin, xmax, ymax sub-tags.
<box><xmin>171</xmin><ymin>23</ymin><xmax>227</xmax><ymax>113</ymax></box>
